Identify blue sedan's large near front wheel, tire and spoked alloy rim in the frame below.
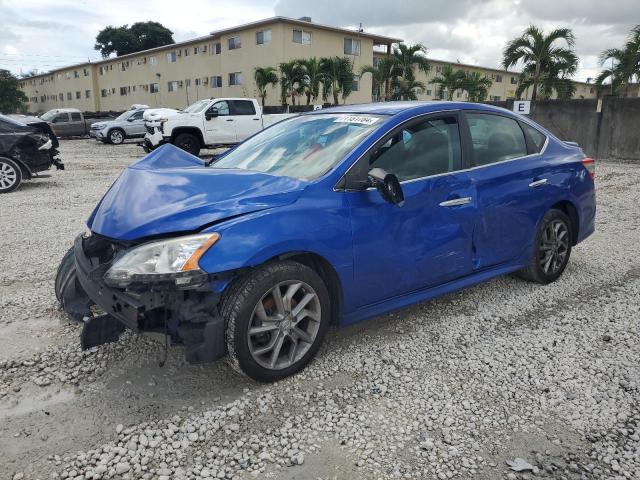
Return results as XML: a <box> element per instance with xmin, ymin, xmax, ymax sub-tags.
<box><xmin>222</xmin><ymin>261</ymin><xmax>330</xmax><ymax>382</ymax></box>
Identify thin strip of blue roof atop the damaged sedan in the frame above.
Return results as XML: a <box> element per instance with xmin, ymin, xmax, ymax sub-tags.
<box><xmin>310</xmin><ymin>101</ymin><xmax>512</xmax><ymax>115</ymax></box>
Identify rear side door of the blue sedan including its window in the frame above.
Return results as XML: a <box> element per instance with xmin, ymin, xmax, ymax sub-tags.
<box><xmin>465</xmin><ymin>111</ymin><xmax>550</xmax><ymax>270</ymax></box>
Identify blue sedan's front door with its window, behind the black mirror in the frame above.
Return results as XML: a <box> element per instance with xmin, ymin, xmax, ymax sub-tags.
<box><xmin>347</xmin><ymin>112</ymin><xmax>476</xmax><ymax>307</ymax></box>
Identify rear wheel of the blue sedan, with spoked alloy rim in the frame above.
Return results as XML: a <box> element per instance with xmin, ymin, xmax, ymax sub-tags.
<box><xmin>518</xmin><ymin>209</ymin><xmax>573</xmax><ymax>285</ymax></box>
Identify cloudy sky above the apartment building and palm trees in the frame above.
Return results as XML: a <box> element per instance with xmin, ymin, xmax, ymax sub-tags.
<box><xmin>0</xmin><ymin>0</ymin><xmax>640</xmax><ymax>81</ymax></box>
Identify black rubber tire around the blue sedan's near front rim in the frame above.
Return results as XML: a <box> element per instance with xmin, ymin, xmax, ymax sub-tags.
<box><xmin>221</xmin><ymin>261</ymin><xmax>331</xmax><ymax>382</ymax></box>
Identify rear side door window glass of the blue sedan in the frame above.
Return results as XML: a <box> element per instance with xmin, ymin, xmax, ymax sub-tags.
<box><xmin>466</xmin><ymin>113</ymin><xmax>527</xmax><ymax>166</ymax></box>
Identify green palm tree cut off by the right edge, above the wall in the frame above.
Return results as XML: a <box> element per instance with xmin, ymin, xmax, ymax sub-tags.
<box><xmin>596</xmin><ymin>25</ymin><xmax>640</xmax><ymax>95</ymax></box>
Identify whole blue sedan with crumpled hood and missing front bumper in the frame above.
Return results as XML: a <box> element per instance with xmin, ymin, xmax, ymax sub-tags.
<box><xmin>56</xmin><ymin>102</ymin><xmax>596</xmax><ymax>381</ymax></box>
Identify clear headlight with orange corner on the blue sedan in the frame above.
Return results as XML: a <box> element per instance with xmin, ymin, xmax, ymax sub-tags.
<box><xmin>104</xmin><ymin>233</ymin><xmax>220</xmax><ymax>287</ymax></box>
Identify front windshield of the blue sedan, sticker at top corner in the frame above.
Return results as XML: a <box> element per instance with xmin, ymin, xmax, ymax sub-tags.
<box><xmin>214</xmin><ymin>114</ymin><xmax>382</xmax><ymax>179</ymax></box>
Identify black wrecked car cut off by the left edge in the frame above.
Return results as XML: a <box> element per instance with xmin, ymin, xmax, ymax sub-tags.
<box><xmin>0</xmin><ymin>115</ymin><xmax>64</xmax><ymax>193</ymax></box>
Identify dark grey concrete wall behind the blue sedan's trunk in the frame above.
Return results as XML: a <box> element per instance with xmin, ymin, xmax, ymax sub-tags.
<box><xmin>490</xmin><ymin>97</ymin><xmax>640</xmax><ymax>162</ymax></box>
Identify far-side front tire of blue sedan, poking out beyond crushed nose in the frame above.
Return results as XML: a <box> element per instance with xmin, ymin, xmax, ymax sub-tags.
<box><xmin>54</xmin><ymin>248</ymin><xmax>92</xmax><ymax>322</ymax></box>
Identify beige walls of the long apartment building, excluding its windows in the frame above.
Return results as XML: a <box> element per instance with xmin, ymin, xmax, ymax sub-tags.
<box><xmin>22</xmin><ymin>22</ymin><xmax>373</xmax><ymax>112</ymax></box>
